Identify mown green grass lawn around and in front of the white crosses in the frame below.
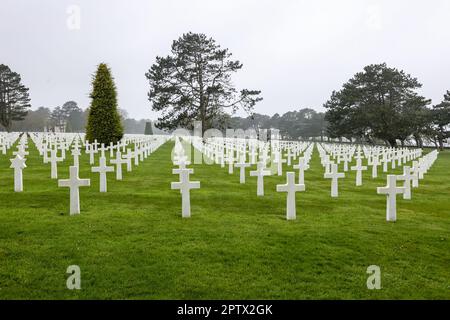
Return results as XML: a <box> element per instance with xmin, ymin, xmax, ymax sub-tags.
<box><xmin>0</xmin><ymin>140</ymin><xmax>450</xmax><ymax>299</ymax></box>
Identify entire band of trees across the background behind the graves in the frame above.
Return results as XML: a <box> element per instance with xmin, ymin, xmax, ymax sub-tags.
<box><xmin>0</xmin><ymin>32</ymin><xmax>450</xmax><ymax>148</ymax></box>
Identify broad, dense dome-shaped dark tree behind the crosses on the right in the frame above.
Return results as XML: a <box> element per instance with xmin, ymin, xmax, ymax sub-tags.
<box><xmin>324</xmin><ymin>63</ymin><xmax>430</xmax><ymax>146</ymax></box>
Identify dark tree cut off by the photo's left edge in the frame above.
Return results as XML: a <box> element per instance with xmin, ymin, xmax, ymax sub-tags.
<box><xmin>0</xmin><ymin>64</ymin><xmax>31</xmax><ymax>131</ymax></box>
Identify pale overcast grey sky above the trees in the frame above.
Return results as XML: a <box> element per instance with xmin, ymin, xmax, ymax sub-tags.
<box><xmin>0</xmin><ymin>0</ymin><xmax>450</xmax><ymax>119</ymax></box>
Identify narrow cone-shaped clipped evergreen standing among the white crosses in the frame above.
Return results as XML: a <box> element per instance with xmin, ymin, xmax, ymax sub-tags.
<box><xmin>86</xmin><ymin>63</ymin><xmax>123</xmax><ymax>144</ymax></box>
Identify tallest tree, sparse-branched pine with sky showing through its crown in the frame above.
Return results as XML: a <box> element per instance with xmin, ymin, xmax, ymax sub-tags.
<box><xmin>145</xmin><ymin>33</ymin><xmax>262</xmax><ymax>130</ymax></box>
